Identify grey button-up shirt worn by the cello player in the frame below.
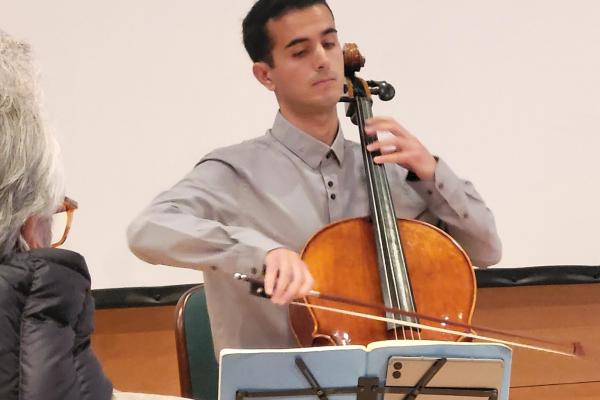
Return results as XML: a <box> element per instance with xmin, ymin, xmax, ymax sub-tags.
<box><xmin>127</xmin><ymin>113</ymin><xmax>501</xmax><ymax>354</ymax></box>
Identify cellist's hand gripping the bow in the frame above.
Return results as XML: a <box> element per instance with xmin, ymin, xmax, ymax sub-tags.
<box><xmin>265</xmin><ymin>248</ymin><xmax>314</xmax><ymax>304</ymax></box>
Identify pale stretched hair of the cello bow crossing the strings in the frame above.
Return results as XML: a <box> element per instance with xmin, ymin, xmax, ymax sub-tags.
<box><xmin>290</xmin><ymin>301</ymin><xmax>578</xmax><ymax>357</ymax></box>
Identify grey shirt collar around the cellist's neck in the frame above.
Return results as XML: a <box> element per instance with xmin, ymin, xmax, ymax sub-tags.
<box><xmin>271</xmin><ymin>112</ymin><xmax>344</xmax><ymax>169</ymax></box>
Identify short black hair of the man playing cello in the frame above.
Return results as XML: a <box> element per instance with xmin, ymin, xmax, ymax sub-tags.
<box><xmin>242</xmin><ymin>0</ymin><xmax>333</xmax><ymax>66</ymax></box>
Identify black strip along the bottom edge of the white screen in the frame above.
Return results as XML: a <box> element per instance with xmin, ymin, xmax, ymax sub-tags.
<box><xmin>92</xmin><ymin>265</ymin><xmax>600</xmax><ymax>309</ymax></box>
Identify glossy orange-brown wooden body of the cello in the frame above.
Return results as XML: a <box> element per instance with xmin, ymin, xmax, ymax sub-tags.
<box><xmin>290</xmin><ymin>217</ymin><xmax>476</xmax><ymax>347</ymax></box>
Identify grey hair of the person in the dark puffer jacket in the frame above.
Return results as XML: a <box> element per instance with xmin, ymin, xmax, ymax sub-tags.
<box><xmin>0</xmin><ymin>30</ymin><xmax>64</xmax><ymax>258</ymax></box>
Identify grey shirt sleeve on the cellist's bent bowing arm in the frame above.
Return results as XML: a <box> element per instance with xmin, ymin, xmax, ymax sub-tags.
<box><xmin>127</xmin><ymin>159</ymin><xmax>284</xmax><ymax>277</ymax></box>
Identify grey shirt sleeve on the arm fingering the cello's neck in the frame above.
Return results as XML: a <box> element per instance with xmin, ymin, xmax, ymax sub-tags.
<box><xmin>408</xmin><ymin>159</ymin><xmax>502</xmax><ymax>267</ymax></box>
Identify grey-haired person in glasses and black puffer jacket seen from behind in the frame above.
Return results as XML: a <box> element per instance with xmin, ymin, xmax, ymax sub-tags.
<box><xmin>0</xmin><ymin>30</ymin><xmax>189</xmax><ymax>400</ymax></box>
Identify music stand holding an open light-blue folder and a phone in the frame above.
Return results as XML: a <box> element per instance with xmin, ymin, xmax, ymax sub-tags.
<box><xmin>219</xmin><ymin>341</ymin><xmax>511</xmax><ymax>400</ymax></box>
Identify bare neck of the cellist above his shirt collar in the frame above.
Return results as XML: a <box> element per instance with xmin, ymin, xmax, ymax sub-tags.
<box><xmin>280</xmin><ymin>107</ymin><xmax>338</xmax><ymax>146</ymax></box>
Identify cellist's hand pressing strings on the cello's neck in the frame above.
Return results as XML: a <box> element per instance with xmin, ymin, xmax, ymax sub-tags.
<box><xmin>365</xmin><ymin>117</ymin><xmax>437</xmax><ymax>180</ymax></box>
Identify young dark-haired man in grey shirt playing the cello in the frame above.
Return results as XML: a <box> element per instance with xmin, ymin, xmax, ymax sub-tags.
<box><xmin>128</xmin><ymin>0</ymin><xmax>501</xmax><ymax>353</ymax></box>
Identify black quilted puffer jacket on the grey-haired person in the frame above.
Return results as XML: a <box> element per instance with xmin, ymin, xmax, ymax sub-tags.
<box><xmin>0</xmin><ymin>249</ymin><xmax>112</xmax><ymax>400</ymax></box>
